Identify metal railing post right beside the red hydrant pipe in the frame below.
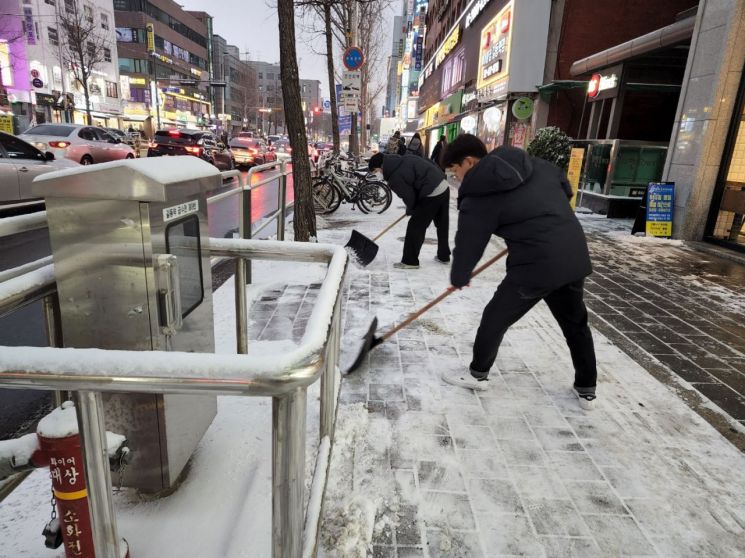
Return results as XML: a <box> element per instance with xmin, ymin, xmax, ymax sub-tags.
<box><xmin>75</xmin><ymin>391</ymin><xmax>121</xmax><ymax>558</ymax></box>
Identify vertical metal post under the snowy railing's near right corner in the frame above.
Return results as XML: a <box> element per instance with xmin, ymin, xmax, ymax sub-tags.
<box><xmin>272</xmin><ymin>388</ymin><xmax>307</xmax><ymax>558</ymax></box>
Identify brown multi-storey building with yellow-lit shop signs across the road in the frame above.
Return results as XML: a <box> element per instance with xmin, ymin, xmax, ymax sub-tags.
<box><xmin>114</xmin><ymin>0</ymin><xmax>214</xmax><ymax>136</ymax></box>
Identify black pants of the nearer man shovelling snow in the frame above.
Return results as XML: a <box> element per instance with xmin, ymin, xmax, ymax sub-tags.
<box><xmin>471</xmin><ymin>278</ymin><xmax>598</xmax><ymax>387</ymax></box>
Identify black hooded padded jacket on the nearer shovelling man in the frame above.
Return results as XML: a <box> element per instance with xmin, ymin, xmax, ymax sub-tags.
<box><xmin>450</xmin><ymin>146</ymin><xmax>592</xmax><ymax>297</ymax></box>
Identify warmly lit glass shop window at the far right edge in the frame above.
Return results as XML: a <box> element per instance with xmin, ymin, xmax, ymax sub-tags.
<box><xmin>706</xmin><ymin>73</ymin><xmax>745</xmax><ymax>252</ymax></box>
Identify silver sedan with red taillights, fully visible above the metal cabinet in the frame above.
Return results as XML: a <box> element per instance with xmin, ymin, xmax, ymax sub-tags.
<box><xmin>19</xmin><ymin>124</ymin><xmax>135</xmax><ymax>165</ymax></box>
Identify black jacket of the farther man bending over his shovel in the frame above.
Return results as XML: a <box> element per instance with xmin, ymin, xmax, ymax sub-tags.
<box><xmin>383</xmin><ymin>154</ymin><xmax>445</xmax><ymax>215</ymax></box>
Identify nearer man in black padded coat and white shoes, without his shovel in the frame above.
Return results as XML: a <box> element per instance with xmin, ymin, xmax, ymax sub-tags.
<box><xmin>443</xmin><ymin>134</ymin><xmax>597</xmax><ymax>409</ymax></box>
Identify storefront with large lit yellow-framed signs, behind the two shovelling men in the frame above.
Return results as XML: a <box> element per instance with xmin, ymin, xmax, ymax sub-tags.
<box><xmin>420</xmin><ymin>0</ymin><xmax>550</xmax><ymax>155</ymax></box>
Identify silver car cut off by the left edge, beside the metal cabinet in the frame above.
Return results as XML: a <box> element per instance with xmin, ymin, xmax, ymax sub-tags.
<box><xmin>0</xmin><ymin>132</ymin><xmax>80</xmax><ymax>205</ymax></box>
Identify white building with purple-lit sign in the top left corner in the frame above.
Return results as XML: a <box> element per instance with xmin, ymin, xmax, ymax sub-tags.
<box><xmin>0</xmin><ymin>0</ymin><xmax>122</xmax><ymax>131</ymax></box>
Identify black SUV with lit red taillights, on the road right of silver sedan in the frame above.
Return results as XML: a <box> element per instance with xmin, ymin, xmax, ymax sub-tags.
<box><xmin>147</xmin><ymin>129</ymin><xmax>236</xmax><ymax>170</ymax></box>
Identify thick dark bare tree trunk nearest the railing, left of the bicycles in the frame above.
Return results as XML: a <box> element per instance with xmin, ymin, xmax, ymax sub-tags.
<box><xmin>277</xmin><ymin>0</ymin><xmax>317</xmax><ymax>242</ymax></box>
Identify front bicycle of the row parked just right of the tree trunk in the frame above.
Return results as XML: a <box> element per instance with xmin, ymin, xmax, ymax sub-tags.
<box><xmin>312</xmin><ymin>159</ymin><xmax>393</xmax><ymax>215</ymax></box>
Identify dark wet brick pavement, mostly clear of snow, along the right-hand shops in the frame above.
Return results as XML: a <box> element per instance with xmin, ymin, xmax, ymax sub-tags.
<box><xmin>581</xmin><ymin>216</ymin><xmax>745</xmax><ymax>436</ymax></box>
